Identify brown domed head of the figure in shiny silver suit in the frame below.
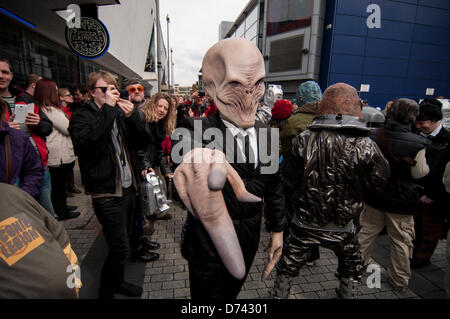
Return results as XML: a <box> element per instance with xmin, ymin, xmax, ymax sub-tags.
<box><xmin>317</xmin><ymin>83</ymin><xmax>363</xmax><ymax>118</ymax></box>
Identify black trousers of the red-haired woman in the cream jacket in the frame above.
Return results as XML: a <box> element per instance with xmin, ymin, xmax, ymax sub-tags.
<box><xmin>48</xmin><ymin>162</ymin><xmax>75</xmax><ymax>216</ymax></box>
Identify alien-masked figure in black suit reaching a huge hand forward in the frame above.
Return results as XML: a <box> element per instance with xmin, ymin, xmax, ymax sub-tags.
<box><xmin>172</xmin><ymin>38</ymin><xmax>286</xmax><ymax>300</ymax></box>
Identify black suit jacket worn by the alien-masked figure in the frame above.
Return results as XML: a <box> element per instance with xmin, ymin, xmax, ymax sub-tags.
<box><xmin>173</xmin><ymin>112</ymin><xmax>287</xmax><ymax>272</ymax></box>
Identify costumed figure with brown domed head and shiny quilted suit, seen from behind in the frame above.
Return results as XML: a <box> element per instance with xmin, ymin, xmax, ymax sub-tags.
<box><xmin>272</xmin><ymin>83</ymin><xmax>390</xmax><ymax>298</ymax></box>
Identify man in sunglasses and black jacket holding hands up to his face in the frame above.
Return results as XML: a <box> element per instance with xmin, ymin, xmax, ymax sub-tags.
<box><xmin>69</xmin><ymin>70</ymin><xmax>146</xmax><ymax>299</ymax></box>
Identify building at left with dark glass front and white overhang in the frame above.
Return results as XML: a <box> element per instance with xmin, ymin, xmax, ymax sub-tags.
<box><xmin>0</xmin><ymin>0</ymin><xmax>167</xmax><ymax>95</ymax></box>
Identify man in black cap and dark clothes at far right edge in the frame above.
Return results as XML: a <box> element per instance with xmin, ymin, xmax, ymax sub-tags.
<box><xmin>411</xmin><ymin>99</ymin><xmax>450</xmax><ymax>268</ymax></box>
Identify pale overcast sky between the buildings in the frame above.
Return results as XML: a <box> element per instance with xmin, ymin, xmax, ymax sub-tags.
<box><xmin>159</xmin><ymin>0</ymin><xmax>248</xmax><ymax>86</ymax></box>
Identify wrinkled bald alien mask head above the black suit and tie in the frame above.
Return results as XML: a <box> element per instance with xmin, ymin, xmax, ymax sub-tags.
<box><xmin>202</xmin><ymin>38</ymin><xmax>265</xmax><ymax>128</ymax></box>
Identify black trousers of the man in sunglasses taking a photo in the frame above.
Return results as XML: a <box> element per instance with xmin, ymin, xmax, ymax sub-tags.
<box><xmin>93</xmin><ymin>187</ymin><xmax>136</xmax><ymax>293</ymax></box>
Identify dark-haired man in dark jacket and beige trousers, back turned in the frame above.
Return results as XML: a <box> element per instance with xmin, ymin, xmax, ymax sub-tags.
<box><xmin>359</xmin><ymin>99</ymin><xmax>428</xmax><ymax>292</ymax></box>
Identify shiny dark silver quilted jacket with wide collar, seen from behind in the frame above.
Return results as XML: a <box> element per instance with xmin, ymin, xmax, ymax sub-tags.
<box><xmin>283</xmin><ymin>115</ymin><xmax>390</xmax><ymax>231</ymax></box>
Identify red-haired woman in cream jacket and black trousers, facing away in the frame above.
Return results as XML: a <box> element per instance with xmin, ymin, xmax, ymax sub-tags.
<box><xmin>34</xmin><ymin>79</ymin><xmax>80</xmax><ymax>220</ymax></box>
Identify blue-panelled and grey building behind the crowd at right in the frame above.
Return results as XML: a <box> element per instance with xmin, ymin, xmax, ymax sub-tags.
<box><xmin>225</xmin><ymin>0</ymin><xmax>450</xmax><ymax>108</ymax></box>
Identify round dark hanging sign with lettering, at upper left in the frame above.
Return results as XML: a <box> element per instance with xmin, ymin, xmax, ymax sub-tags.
<box><xmin>66</xmin><ymin>17</ymin><xmax>109</xmax><ymax>59</ymax></box>
